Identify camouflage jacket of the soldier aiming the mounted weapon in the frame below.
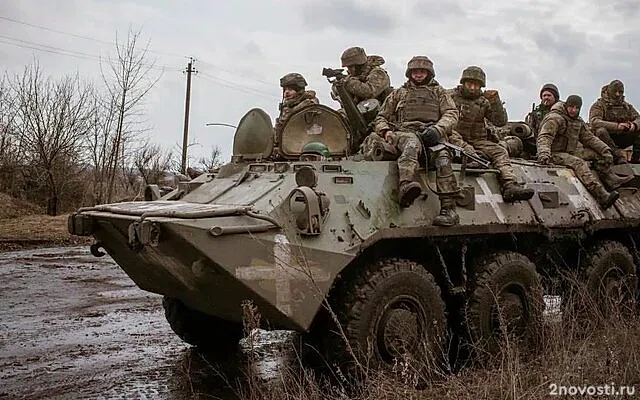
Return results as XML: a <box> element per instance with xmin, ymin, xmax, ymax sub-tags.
<box><xmin>332</xmin><ymin>56</ymin><xmax>391</xmax><ymax>104</ymax></box>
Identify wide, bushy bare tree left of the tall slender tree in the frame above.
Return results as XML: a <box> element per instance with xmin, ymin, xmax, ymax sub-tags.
<box><xmin>12</xmin><ymin>62</ymin><xmax>92</xmax><ymax>215</ymax></box>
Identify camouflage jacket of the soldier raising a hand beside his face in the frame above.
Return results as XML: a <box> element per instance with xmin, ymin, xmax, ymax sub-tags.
<box><xmin>448</xmin><ymin>86</ymin><xmax>507</xmax><ymax>142</ymax></box>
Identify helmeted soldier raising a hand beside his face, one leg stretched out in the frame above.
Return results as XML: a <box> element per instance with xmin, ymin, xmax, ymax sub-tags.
<box><xmin>449</xmin><ymin>66</ymin><xmax>534</xmax><ymax>203</ymax></box>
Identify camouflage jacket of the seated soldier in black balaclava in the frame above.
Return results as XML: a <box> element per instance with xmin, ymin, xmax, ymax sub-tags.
<box><xmin>536</xmin><ymin>101</ymin><xmax>610</xmax><ymax>157</ymax></box>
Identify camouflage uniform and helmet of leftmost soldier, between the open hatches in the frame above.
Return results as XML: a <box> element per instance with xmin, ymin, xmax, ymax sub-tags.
<box><xmin>272</xmin><ymin>72</ymin><xmax>320</xmax><ymax>158</ymax></box>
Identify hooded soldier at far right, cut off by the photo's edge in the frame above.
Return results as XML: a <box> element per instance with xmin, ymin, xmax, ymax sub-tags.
<box><xmin>589</xmin><ymin>80</ymin><xmax>640</xmax><ymax>164</ymax></box>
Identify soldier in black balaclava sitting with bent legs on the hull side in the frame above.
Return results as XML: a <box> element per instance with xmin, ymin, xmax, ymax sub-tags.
<box><xmin>537</xmin><ymin>95</ymin><xmax>633</xmax><ymax>209</ymax></box>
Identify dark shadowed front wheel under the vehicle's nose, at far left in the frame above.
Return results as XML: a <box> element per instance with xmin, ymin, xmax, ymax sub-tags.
<box><xmin>162</xmin><ymin>296</ymin><xmax>242</xmax><ymax>355</ymax></box>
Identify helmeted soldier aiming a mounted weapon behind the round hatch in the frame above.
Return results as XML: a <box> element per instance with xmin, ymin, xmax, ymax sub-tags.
<box><xmin>331</xmin><ymin>47</ymin><xmax>392</xmax><ymax>104</ymax></box>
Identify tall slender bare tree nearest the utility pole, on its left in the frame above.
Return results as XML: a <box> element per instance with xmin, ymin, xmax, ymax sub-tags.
<box><xmin>100</xmin><ymin>29</ymin><xmax>162</xmax><ymax>201</ymax></box>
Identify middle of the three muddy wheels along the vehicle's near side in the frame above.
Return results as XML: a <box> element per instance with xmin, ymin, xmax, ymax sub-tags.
<box><xmin>465</xmin><ymin>251</ymin><xmax>544</xmax><ymax>359</ymax></box>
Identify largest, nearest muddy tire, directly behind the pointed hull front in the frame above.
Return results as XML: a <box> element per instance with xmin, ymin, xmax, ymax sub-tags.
<box><xmin>327</xmin><ymin>259</ymin><xmax>447</xmax><ymax>382</ymax></box>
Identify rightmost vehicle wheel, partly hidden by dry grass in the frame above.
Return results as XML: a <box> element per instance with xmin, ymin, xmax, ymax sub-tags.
<box><xmin>567</xmin><ymin>240</ymin><xmax>638</xmax><ymax>320</ymax></box>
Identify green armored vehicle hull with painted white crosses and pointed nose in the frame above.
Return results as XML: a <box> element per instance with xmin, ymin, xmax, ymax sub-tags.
<box><xmin>70</xmin><ymin>160</ymin><xmax>640</xmax><ymax>331</ymax></box>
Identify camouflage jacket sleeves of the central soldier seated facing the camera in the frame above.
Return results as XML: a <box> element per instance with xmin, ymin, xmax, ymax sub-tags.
<box><xmin>373</xmin><ymin>79</ymin><xmax>460</xmax><ymax>137</ymax></box>
